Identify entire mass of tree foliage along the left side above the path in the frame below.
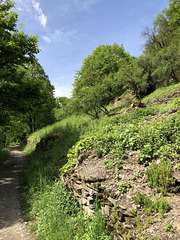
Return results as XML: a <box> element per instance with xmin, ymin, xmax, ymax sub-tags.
<box><xmin>0</xmin><ymin>0</ymin><xmax>55</xmax><ymax>147</ymax></box>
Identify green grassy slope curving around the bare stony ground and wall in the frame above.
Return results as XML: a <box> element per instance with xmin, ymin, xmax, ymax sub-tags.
<box><xmin>22</xmin><ymin>84</ymin><xmax>180</xmax><ymax>240</ymax></box>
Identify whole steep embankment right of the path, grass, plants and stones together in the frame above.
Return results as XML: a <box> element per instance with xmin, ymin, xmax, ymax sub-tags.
<box><xmin>24</xmin><ymin>84</ymin><xmax>180</xmax><ymax>240</ymax></box>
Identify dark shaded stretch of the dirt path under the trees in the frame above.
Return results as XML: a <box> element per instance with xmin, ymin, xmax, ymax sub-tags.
<box><xmin>0</xmin><ymin>149</ymin><xmax>27</xmax><ymax>229</ymax></box>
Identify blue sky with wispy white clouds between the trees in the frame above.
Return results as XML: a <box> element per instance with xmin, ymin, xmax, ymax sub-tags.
<box><xmin>15</xmin><ymin>0</ymin><xmax>168</xmax><ymax>97</ymax></box>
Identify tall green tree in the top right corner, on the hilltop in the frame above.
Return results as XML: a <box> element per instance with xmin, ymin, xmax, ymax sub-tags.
<box><xmin>144</xmin><ymin>0</ymin><xmax>180</xmax><ymax>88</ymax></box>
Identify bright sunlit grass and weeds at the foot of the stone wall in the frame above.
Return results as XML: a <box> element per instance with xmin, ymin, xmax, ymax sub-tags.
<box><xmin>28</xmin><ymin>182</ymin><xmax>111</xmax><ymax>240</ymax></box>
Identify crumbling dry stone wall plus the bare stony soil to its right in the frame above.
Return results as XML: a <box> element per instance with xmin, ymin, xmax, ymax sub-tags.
<box><xmin>62</xmin><ymin>151</ymin><xmax>180</xmax><ymax>240</ymax></box>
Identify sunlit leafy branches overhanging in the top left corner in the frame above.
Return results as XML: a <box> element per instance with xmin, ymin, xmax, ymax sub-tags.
<box><xmin>0</xmin><ymin>0</ymin><xmax>39</xmax><ymax>69</ymax></box>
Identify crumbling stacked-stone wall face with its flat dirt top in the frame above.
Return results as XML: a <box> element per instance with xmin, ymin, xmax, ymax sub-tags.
<box><xmin>62</xmin><ymin>150</ymin><xmax>139</xmax><ymax>240</ymax></box>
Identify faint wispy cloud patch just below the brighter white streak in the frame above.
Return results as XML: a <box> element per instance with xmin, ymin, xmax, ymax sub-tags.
<box><xmin>42</xmin><ymin>29</ymin><xmax>77</xmax><ymax>43</ymax></box>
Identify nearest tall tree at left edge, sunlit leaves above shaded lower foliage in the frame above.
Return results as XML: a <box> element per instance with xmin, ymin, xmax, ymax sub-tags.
<box><xmin>0</xmin><ymin>0</ymin><xmax>39</xmax><ymax>116</ymax></box>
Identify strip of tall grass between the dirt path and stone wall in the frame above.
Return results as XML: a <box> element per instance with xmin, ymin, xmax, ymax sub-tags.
<box><xmin>21</xmin><ymin>116</ymin><xmax>111</xmax><ymax>240</ymax></box>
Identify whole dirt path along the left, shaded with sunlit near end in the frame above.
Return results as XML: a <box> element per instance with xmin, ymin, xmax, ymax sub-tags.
<box><xmin>0</xmin><ymin>147</ymin><xmax>34</xmax><ymax>240</ymax></box>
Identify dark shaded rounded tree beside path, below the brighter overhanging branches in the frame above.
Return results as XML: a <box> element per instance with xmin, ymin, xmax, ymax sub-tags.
<box><xmin>0</xmin><ymin>62</ymin><xmax>55</xmax><ymax>144</ymax></box>
